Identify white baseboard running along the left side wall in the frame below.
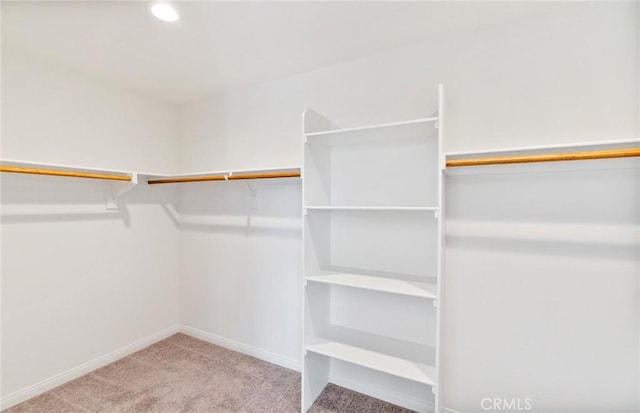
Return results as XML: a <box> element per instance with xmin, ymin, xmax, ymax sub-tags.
<box><xmin>0</xmin><ymin>325</ymin><xmax>180</xmax><ymax>410</ymax></box>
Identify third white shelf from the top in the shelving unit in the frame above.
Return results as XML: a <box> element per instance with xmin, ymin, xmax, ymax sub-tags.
<box><xmin>305</xmin><ymin>273</ymin><xmax>437</xmax><ymax>299</ymax></box>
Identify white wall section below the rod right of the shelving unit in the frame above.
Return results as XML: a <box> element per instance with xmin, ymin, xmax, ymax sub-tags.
<box><xmin>444</xmin><ymin>160</ymin><xmax>640</xmax><ymax>412</ymax></box>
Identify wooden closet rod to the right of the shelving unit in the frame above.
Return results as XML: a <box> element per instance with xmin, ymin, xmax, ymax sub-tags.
<box><xmin>447</xmin><ymin>148</ymin><xmax>640</xmax><ymax>168</ymax></box>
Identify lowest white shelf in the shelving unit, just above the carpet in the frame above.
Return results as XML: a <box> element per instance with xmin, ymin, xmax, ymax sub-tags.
<box><xmin>305</xmin><ymin>341</ymin><xmax>435</xmax><ymax>386</ymax></box>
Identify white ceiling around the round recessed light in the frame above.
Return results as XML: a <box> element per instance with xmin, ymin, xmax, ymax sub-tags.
<box><xmin>2</xmin><ymin>1</ymin><xmax>558</xmax><ymax>103</ymax></box>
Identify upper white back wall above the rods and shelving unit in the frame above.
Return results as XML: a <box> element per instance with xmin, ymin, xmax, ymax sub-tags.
<box><xmin>180</xmin><ymin>2</ymin><xmax>640</xmax><ymax>170</ymax></box>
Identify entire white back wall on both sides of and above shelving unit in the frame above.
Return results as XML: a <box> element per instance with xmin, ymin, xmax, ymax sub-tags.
<box><xmin>180</xmin><ymin>2</ymin><xmax>640</xmax><ymax>412</ymax></box>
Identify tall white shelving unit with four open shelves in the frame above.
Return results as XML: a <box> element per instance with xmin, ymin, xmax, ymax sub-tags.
<box><xmin>302</xmin><ymin>86</ymin><xmax>445</xmax><ymax>413</ymax></box>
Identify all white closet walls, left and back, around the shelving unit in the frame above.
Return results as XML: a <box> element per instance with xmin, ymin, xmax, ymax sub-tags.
<box><xmin>1</xmin><ymin>3</ymin><xmax>640</xmax><ymax>412</ymax></box>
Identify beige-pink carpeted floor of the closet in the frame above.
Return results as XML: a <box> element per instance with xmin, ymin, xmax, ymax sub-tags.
<box><xmin>4</xmin><ymin>334</ymin><xmax>416</xmax><ymax>413</ymax></box>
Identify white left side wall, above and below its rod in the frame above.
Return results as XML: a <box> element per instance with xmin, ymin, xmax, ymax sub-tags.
<box><xmin>0</xmin><ymin>53</ymin><xmax>178</xmax><ymax>407</ymax></box>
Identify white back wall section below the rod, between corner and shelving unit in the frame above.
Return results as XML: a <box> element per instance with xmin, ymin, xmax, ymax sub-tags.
<box><xmin>176</xmin><ymin>179</ymin><xmax>302</xmax><ymax>369</ymax></box>
